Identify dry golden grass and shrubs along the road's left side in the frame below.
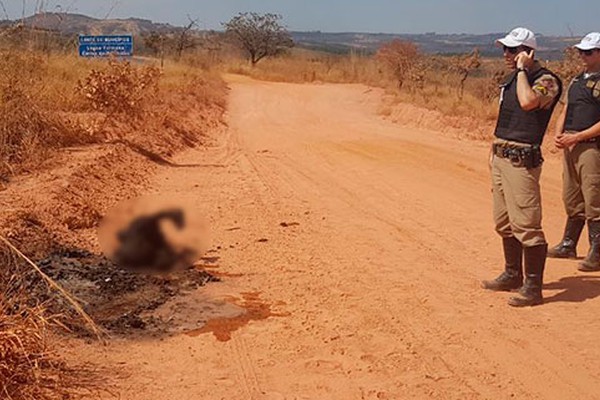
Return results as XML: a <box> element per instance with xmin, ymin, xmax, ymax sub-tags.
<box><xmin>0</xmin><ymin>29</ymin><xmax>226</xmax><ymax>400</ymax></box>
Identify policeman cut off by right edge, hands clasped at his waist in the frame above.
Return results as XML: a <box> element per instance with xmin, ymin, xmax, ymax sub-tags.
<box><xmin>548</xmin><ymin>32</ymin><xmax>600</xmax><ymax>271</ymax></box>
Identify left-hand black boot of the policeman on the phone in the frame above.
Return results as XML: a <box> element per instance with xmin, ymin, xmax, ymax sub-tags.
<box><xmin>481</xmin><ymin>237</ymin><xmax>523</xmax><ymax>291</ymax></box>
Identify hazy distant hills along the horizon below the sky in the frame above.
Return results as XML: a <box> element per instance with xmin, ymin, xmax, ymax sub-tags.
<box><xmin>0</xmin><ymin>13</ymin><xmax>577</xmax><ymax>60</ymax></box>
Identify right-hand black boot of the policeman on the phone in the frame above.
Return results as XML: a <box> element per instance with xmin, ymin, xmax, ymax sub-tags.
<box><xmin>508</xmin><ymin>244</ymin><xmax>548</xmax><ymax>307</ymax></box>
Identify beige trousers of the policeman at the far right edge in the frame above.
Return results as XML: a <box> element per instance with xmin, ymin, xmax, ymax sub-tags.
<box><xmin>563</xmin><ymin>143</ymin><xmax>600</xmax><ymax>221</ymax></box>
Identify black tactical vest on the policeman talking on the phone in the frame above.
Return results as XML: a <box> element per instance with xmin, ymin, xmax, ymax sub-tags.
<box><xmin>494</xmin><ymin>68</ymin><xmax>562</xmax><ymax>145</ymax></box>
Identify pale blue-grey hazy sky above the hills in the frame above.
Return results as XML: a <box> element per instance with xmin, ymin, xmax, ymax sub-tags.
<box><xmin>0</xmin><ymin>0</ymin><xmax>600</xmax><ymax>36</ymax></box>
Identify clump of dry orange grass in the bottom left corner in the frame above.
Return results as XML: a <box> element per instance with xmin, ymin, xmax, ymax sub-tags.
<box><xmin>0</xmin><ymin>247</ymin><xmax>102</xmax><ymax>400</ymax></box>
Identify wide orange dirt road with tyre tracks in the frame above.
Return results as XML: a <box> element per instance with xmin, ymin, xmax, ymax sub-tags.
<box><xmin>72</xmin><ymin>79</ymin><xmax>600</xmax><ymax>400</ymax></box>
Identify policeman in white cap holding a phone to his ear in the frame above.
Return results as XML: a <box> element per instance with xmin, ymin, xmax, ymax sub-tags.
<box><xmin>482</xmin><ymin>28</ymin><xmax>562</xmax><ymax>307</ymax></box>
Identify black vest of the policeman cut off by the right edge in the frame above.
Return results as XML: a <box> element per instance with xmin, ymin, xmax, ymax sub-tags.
<box><xmin>565</xmin><ymin>74</ymin><xmax>600</xmax><ymax>132</ymax></box>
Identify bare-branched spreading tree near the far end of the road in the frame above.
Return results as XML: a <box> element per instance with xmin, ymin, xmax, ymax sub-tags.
<box><xmin>223</xmin><ymin>13</ymin><xmax>294</xmax><ymax>66</ymax></box>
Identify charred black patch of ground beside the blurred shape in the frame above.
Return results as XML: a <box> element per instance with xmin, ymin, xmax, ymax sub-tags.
<box><xmin>27</xmin><ymin>250</ymin><xmax>219</xmax><ymax>336</ymax></box>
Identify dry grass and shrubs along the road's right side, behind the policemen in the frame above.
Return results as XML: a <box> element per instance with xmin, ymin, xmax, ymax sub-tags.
<box><xmin>223</xmin><ymin>40</ymin><xmax>581</xmax><ymax>139</ymax></box>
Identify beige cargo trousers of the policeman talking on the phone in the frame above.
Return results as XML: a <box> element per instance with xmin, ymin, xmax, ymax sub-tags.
<box><xmin>491</xmin><ymin>142</ymin><xmax>546</xmax><ymax>247</ymax></box>
